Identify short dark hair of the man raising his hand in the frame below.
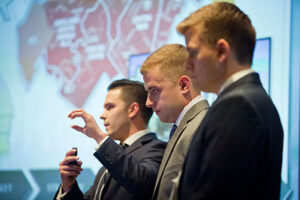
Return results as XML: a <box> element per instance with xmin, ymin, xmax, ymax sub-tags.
<box><xmin>107</xmin><ymin>79</ymin><xmax>153</xmax><ymax>124</ymax></box>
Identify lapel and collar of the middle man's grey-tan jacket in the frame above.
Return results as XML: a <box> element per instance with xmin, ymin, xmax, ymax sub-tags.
<box><xmin>154</xmin><ymin>100</ymin><xmax>209</xmax><ymax>192</ymax></box>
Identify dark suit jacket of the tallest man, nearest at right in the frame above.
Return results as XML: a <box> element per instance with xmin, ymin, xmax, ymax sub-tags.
<box><xmin>179</xmin><ymin>73</ymin><xmax>283</xmax><ymax>200</ymax></box>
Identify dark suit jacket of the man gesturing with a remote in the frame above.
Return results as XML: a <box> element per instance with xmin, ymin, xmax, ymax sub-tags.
<box><xmin>55</xmin><ymin>133</ymin><xmax>166</xmax><ymax>200</ymax></box>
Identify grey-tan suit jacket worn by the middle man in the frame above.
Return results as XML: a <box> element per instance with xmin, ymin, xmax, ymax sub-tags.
<box><xmin>152</xmin><ymin>100</ymin><xmax>209</xmax><ymax>200</ymax></box>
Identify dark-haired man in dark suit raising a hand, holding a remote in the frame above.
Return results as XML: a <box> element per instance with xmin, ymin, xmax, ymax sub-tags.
<box><xmin>55</xmin><ymin>79</ymin><xmax>165</xmax><ymax>199</ymax></box>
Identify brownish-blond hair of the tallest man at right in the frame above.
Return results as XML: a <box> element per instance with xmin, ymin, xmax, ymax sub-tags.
<box><xmin>177</xmin><ymin>2</ymin><xmax>256</xmax><ymax>64</ymax></box>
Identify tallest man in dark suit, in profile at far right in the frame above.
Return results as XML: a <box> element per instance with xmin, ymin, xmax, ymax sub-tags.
<box><xmin>177</xmin><ymin>2</ymin><xmax>283</xmax><ymax>200</ymax></box>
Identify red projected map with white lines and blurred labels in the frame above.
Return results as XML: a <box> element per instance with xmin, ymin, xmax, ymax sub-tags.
<box><xmin>18</xmin><ymin>0</ymin><xmax>182</xmax><ymax>107</ymax></box>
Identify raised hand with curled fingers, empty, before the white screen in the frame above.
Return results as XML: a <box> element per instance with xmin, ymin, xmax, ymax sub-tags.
<box><xmin>68</xmin><ymin>109</ymin><xmax>106</xmax><ymax>143</ymax></box>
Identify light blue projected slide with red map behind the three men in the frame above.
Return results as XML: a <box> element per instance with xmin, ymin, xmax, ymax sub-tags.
<box><xmin>0</xmin><ymin>0</ymin><xmax>290</xmax><ymax>200</ymax></box>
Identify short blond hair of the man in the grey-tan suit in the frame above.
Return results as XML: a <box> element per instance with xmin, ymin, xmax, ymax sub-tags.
<box><xmin>140</xmin><ymin>44</ymin><xmax>188</xmax><ymax>81</ymax></box>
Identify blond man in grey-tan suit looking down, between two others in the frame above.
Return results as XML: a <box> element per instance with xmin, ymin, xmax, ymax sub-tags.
<box><xmin>141</xmin><ymin>44</ymin><xmax>209</xmax><ymax>200</ymax></box>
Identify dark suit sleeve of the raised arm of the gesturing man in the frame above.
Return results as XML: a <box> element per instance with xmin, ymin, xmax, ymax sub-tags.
<box><xmin>94</xmin><ymin>138</ymin><xmax>165</xmax><ymax>197</ymax></box>
